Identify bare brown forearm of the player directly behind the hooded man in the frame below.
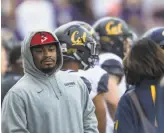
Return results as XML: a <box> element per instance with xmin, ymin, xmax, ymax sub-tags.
<box><xmin>93</xmin><ymin>94</ymin><xmax>106</xmax><ymax>133</ymax></box>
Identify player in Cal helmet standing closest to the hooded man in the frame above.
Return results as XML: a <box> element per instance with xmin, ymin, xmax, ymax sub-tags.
<box><xmin>55</xmin><ymin>22</ymin><xmax>109</xmax><ymax>133</ymax></box>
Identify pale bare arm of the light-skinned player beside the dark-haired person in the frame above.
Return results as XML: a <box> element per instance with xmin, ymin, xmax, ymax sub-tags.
<box><xmin>104</xmin><ymin>75</ymin><xmax>120</xmax><ymax>120</ymax></box>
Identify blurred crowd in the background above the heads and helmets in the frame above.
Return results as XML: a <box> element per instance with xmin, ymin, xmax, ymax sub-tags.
<box><xmin>1</xmin><ymin>0</ymin><xmax>164</xmax><ymax>73</ymax></box>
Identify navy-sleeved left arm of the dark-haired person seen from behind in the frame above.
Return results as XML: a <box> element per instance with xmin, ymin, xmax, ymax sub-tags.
<box><xmin>114</xmin><ymin>95</ymin><xmax>137</xmax><ymax>133</ymax></box>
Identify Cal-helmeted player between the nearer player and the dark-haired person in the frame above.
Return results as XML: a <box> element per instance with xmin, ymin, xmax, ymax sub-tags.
<box><xmin>93</xmin><ymin>17</ymin><xmax>133</xmax><ymax>133</ymax></box>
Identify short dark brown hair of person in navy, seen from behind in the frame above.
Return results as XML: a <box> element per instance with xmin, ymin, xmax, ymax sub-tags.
<box><xmin>124</xmin><ymin>38</ymin><xmax>164</xmax><ymax>85</ymax></box>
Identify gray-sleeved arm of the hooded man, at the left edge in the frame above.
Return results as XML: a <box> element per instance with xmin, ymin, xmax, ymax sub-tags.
<box><xmin>2</xmin><ymin>92</ymin><xmax>29</xmax><ymax>133</ymax></box>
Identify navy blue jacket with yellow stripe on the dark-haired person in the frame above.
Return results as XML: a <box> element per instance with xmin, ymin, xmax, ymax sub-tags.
<box><xmin>114</xmin><ymin>80</ymin><xmax>158</xmax><ymax>133</ymax></box>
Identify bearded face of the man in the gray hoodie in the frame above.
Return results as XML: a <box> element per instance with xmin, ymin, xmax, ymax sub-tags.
<box><xmin>31</xmin><ymin>44</ymin><xmax>57</xmax><ymax>73</ymax></box>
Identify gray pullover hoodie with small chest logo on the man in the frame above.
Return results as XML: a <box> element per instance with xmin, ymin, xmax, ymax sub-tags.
<box><xmin>2</xmin><ymin>32</ymin><xmax>98</xmax><ymax>133</ymax></box>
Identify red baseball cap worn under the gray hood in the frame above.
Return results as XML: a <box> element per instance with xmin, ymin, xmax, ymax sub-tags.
<box><xmin>30</xmin><ymin>32</ymin><xmax>58</xmax><ymax>47</ymax></box>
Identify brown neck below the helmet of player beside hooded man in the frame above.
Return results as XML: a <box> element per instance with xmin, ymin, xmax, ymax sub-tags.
<box><xmin>62</xmin><ymin>62</ymin><xmax>79</xmax><ymax>72</ymax></box>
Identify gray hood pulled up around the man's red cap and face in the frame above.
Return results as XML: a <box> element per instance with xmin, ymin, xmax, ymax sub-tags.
<box><xmin>21</xmin><ymin>30</ymin><xmax>63</xmax><ymax>78</ymax></box>
